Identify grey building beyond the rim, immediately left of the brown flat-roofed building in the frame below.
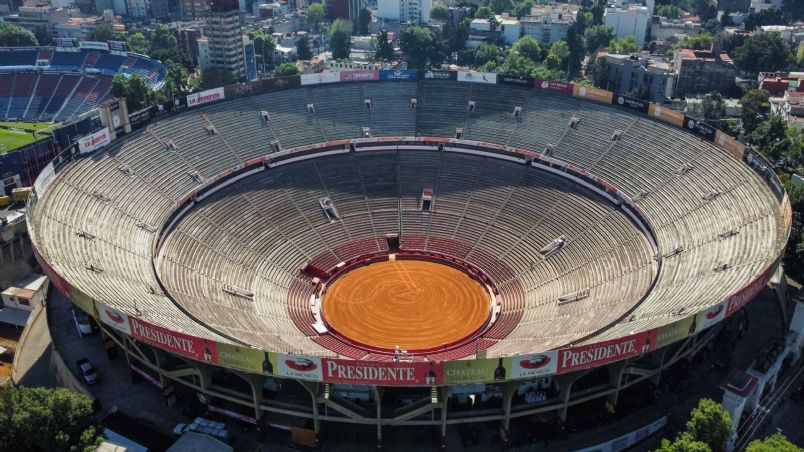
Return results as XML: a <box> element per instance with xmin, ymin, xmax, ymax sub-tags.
<box><xmin>603</xmin><ymin>54</ymin><xmax>676</xmax><ymax>103</ymax></box>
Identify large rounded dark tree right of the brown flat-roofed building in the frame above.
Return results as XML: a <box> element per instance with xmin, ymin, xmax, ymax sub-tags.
<box><xmin>732</xmin><ymin>33</ymin><xmax>793</xmax><ymax>74</ymax></box>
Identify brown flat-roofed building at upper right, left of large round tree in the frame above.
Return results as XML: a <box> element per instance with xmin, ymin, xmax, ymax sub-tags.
<box><xmin>673</xmin><ymin>49</ymin><xmax>736</xmax><ymax>97</ymax></box>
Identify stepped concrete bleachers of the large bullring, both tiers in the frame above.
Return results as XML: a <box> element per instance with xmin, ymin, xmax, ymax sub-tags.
<box><xmin>29</xmin><ymin>80</ymin><xmax>784</xmax><ymax>359</ymax></box>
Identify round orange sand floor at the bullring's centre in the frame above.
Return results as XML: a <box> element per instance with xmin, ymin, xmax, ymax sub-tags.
<box><xmin>322</xmin><ymin>260</ymin><xmax>491</xmax><ymax>350</ymax></box>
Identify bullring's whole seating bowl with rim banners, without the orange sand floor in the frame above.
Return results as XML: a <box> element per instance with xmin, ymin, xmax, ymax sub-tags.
<box><xmin>28</xmin><ymin>71</ymin><xmax>791</xmax><ymax>386</ymax></box>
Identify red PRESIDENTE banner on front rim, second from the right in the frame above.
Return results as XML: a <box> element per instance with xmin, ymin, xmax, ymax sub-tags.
<box><xmin>558</xmin><ymin>329</ymin><xmax>656</xmax><ymax>373</ymax></box>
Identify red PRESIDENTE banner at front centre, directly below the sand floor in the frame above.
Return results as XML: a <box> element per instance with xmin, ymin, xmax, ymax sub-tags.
<box><xmin>323</xmin><ymin>359</ymin><xmax>442</xmax><ymax>386</ymax></box>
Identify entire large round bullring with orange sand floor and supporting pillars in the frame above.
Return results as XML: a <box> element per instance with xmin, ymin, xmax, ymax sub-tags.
<box><xmin>27</xmin><ymin>70</ymin><xmax>791</xmax><ymax>441</ymax></box>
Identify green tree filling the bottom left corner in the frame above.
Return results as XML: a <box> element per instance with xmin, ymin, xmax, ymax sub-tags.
<box><xmin>0</xmin><ymin>384</ymin><xmax>103</xmax><ymax>452</ymax></box>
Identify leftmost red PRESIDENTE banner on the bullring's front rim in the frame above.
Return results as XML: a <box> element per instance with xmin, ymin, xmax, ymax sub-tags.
<box><xmin>128</xmin><ymin>316</ymin><xmax>218</xmax><ymax>364</ymax></box>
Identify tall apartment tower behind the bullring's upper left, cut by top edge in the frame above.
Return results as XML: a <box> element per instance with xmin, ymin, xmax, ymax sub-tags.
<box><xmin>206</xmin><ymin>0</ymin><xmax>246</xmax><ymax>79</ymax></box>
